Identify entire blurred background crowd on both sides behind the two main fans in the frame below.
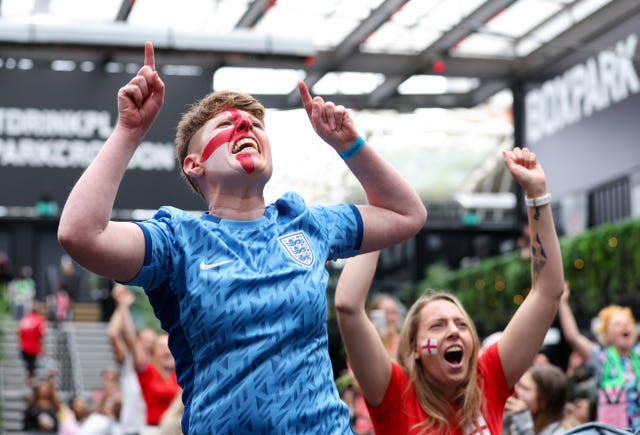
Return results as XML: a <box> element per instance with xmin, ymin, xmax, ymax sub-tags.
<box><xmin>5</xmin><ymin>242</ymin><xmax>640</xmax><ymax>435</ymax></box>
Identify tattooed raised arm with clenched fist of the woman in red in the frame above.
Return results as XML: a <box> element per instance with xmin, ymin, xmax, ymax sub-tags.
<box><xmin>498</xmin><ymin>148</ymin><xmax>564</xmax><ymax>387</ymax></box>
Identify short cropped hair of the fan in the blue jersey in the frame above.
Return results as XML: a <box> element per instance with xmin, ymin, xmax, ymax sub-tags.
<box><xmin>175</xmin><ymin>91</ymin><xmax>265</xmax><ymax>193</ymax></box>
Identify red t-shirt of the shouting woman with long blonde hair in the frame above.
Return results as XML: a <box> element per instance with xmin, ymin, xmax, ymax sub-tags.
<box><xmin>368</xmin><ymin>343</ymin><xmax>511</xmax><ymax>435</ymax></box>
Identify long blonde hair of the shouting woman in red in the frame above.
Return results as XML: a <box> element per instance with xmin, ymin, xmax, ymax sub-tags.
<box><xmin>398</xmin><ymin>290</ymin><xmax>484</xmax><ymax>434</ymax></box>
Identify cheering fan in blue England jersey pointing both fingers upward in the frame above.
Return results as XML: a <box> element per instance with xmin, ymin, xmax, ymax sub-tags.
<box><xmin>58</xmin><ymin>43</ymin><xmax>426</xmax><ymax>434</ymax></box>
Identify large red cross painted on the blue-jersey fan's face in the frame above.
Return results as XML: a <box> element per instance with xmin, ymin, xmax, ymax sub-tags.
<box><xmin>200</xmin><ymin>108</ymin><xmax>258</xmax><ymax>173</ymax></box>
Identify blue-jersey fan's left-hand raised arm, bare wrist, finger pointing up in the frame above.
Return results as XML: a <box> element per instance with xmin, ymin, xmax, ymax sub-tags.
<box><xmin>58</xmin><ymin>42</ymin><xmax>164</xmax><ymax>281</ymax></box>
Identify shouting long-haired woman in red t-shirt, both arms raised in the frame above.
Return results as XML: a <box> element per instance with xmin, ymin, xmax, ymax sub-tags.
<box><xmin>335</xmin><ymin>148</ymin><xmax>564</xmax><ymax>435</ymax></box>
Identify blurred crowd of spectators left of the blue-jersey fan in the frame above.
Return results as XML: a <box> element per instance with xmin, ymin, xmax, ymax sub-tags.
<box><xmin>0</xmin><ymin>253</ymin><xmax>183</xmax><ymax>435</ymax></box>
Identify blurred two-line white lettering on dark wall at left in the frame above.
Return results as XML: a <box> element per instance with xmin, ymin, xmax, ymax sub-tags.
<box><xmin>0</xmin><ymin>107</ymin><xmax>175</xmax><ymax>171</ymax></box>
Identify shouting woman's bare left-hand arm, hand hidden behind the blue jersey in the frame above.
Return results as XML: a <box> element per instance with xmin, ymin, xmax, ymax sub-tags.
<box><xmin>335</xmin><ymin>251</ymin><xmax>391</xmax><ymax>406</ymax></box>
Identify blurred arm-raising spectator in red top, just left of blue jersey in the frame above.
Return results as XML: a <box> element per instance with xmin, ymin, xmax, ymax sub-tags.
<box><xmin>118</xmin><ymin>286</ymin><xmax>180</xmax><ymax>426</ymax></box>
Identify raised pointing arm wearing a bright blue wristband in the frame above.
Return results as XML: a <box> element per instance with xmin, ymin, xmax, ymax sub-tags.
<box><xmin>298</xmin><ymin>82</ymin><xmax>427</xmax><ymax>252</ymax></box>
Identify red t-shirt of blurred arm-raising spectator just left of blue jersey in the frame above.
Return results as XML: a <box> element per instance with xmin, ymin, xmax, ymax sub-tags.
<box><xmin>138</xmin><ymin>364</ymin><xmax>180</xmax><ymax>425</ymax></box>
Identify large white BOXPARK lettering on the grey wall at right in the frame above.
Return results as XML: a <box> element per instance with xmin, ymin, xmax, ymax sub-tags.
<box><xmin>525</xmin><ymin>34</ymin><xmax>640</xmax><ymax>144</ymax></box>
